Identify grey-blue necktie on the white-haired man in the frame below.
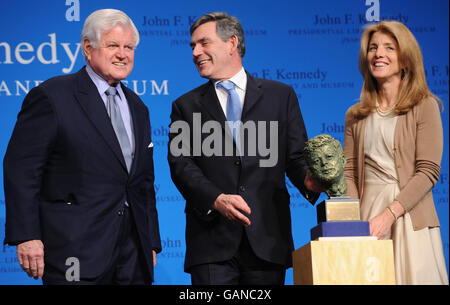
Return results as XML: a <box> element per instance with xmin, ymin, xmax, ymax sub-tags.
<box><xmin>105</xmin><ymin>87</ymin><xmax>133</xmax><ymax>172</ymax></box>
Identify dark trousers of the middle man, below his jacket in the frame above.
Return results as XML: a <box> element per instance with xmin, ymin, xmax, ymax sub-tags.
<box><xmin>189</xmin><ymin>232</ymin><xmax>286</xmax><ymax>285</ymax></box>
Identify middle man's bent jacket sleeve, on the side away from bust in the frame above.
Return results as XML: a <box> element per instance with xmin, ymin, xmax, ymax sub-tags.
<box><xmin>168</xmin><ymin>102</ymin><xmax>223</xmax><ymax>220</ymax></box>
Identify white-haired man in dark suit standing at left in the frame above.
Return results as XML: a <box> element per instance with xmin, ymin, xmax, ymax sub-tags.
<box><xmin>3</xmin><ymin>9</ymin><xmax>161</xmax><ymax>284</ymax></box>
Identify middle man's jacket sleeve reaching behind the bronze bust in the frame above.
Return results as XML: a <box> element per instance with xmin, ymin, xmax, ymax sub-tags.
<box><xmin>286</xmin><ymin>88</ymin><xmax>320</xmax><ymax>204</ymax></box>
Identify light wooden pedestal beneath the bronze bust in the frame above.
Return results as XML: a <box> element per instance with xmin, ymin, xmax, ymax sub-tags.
<box><xmin>293</xmin><ymin>236</ymin><xmax>395</xmax><ymax>285</ymax></box>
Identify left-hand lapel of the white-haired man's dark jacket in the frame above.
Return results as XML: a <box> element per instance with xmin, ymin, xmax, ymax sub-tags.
<box><xmin>75</xmin><ymin>68</ymin><xmax>127</xmax><ymax>171</ymax></box>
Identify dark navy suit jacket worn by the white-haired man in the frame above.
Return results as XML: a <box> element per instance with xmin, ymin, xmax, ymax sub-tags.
<box><xmin>3</xmin><ymin>68</ymin><xmax>161</xmax><ymax>278</ymax></box>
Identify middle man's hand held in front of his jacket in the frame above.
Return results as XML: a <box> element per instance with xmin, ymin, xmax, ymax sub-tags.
<box><xmin>214</xmin><ymin>194</ymin><xmax>251</xmax><ymax>227</ymax></box>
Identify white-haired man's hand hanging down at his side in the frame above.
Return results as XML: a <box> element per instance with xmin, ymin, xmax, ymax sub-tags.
<box><xmin>17</xmin><ymin>239</ymin><xmax>44</xmax><ymax>280</ymax></box>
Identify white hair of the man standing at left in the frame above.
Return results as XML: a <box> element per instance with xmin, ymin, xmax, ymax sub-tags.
<box><xmin>81</xmin><ymin>9</ymin><xmax>139</xmax><ymax>58</ymax></box>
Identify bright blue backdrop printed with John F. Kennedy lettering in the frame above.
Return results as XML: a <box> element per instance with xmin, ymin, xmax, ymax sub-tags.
<box><xmin>0</xmin><ymin>0</ymin><xmax>449</xmax><ymax>285</ymax></box>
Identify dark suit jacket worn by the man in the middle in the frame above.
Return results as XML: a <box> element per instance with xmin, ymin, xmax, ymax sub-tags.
<box><xmin>168</xmin><ymin>73</ymin><xmax>318</xmax><ymax>271</ymax></box>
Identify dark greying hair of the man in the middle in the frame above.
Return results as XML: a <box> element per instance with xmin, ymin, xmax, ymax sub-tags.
<box><xmin>191</xmin><ymin>12</ymin><xmax>245</xmax><ymax>58</ymax></box>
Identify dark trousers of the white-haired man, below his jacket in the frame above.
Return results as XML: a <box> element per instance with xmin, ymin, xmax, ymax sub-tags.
<box><xmin>42</xmin><ymin>206</ymin><xmax>152</xmax><ymax>285</ymax></box>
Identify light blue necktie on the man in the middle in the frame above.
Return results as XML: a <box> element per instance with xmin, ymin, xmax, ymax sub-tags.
<box><xmin>217</xmin><ymin>81</ymin><xmax>242</xmax><ymax>151</ymax></box>
